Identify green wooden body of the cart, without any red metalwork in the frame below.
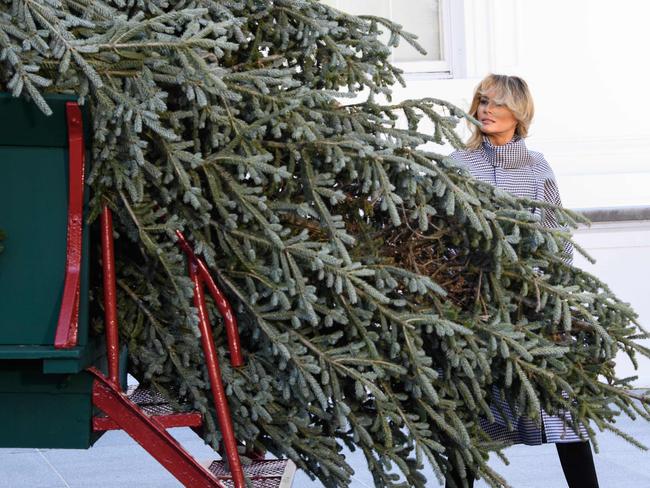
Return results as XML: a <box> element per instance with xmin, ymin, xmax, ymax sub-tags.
<box><xmin>0</xmin><ymin>94</ymin><xmax>100</xmax><ymax>448</ymax></box>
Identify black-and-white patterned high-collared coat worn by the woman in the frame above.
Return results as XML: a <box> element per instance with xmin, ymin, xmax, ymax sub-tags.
<box><xmin>450</xmin><ymin>137</ymin><xmax>587</xmax><ymax>445</ymax></box>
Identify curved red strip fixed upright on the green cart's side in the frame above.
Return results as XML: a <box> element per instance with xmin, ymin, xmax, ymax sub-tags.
<box><xmin>54</xmin><ymin>102</ymin><xmax>84</xmax><ymax>349</ymax></box>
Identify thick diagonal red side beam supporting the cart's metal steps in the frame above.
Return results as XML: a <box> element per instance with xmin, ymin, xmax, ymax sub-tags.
<box><xmin>88</xmin><ymin>368</ymin><xmax>225</xmax><ymax>488</ymax></box>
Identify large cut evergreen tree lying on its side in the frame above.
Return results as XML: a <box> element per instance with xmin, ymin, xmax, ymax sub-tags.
<box><xmin>0</xmin><ymin>0</ymin><xmax>648</xmax><ymax>486</ymax></box>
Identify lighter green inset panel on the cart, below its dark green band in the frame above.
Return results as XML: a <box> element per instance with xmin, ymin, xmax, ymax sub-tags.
<box><xmin>0</xmin><ymin>146</ymin><xmax>67</xmax><ymax>345</ymax></box>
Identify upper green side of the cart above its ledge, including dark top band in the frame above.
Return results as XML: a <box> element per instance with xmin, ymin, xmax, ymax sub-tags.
<box><xmin>0</xmin><ymin>95</ymin><xmax>89</xmax><ymax>347</ymax></box>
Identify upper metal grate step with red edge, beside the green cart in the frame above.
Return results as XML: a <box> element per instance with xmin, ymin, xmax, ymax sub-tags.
<box><xmin>93</xmin><ymin>386</ymin><xmax>203</xmax><ymax>431</ymax></box>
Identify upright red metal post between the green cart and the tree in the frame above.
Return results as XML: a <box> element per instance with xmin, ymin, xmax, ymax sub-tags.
<box><xmin>101</xmin><ymin>206</ymin><xmax>120</xmax><ymax>385</ymax></box>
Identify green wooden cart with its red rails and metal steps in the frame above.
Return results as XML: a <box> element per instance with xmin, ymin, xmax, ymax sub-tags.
<box><xmin>0</xmin><ymin>94</ymin><xmax>295</xmax><ymax>488</ymax></box>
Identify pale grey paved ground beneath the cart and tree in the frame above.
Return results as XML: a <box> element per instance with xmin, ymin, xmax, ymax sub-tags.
<box><xmin>0</xmin><ymin>419</ymin><xmax>650</xmax><ymax>488</ymax></box>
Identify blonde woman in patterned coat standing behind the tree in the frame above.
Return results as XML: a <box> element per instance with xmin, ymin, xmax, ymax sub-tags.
<box><xmin>448</xmin><ymin>75</ymin><xmax>598</xmax><ymax>488</ymax></box>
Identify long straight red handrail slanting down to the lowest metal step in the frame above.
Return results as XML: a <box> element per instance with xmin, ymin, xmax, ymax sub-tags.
<box><xmin>189</xmin><ymin>259</ymin><xmax>246</xmax><ymax>488</ymax></box>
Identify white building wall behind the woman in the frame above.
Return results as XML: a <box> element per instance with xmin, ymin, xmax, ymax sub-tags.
<box><xmin>382</xmin><ymin>0</ymin><xmax>650</xmax><ymax>386</ymax></box>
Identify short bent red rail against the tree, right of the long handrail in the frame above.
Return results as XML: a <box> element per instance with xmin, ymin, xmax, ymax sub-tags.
<box><xmin>176</xmin><ymin>230</ymin><xmax>244</xmax><ymax>368</ymax></box>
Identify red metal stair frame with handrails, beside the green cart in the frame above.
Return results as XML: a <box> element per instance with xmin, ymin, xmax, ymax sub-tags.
<box><xmin>89</xmin><ymin>210</ymin><xmax>246</xmax><ymax>488</ymax></box>
